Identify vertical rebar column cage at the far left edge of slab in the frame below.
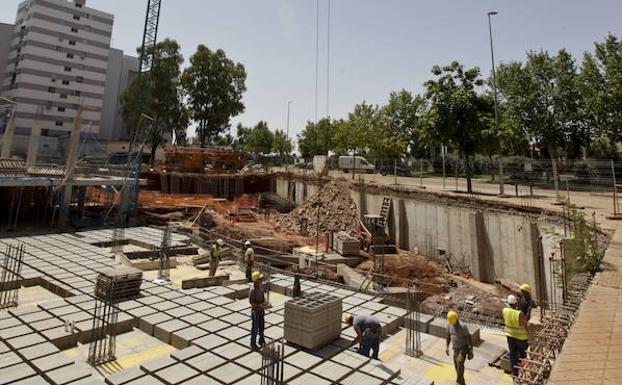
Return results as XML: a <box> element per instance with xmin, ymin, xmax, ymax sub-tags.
<box><xmin>0</xmin><ymin>244</ymin><xmax>24</xmax><ymax>310</ymax></box>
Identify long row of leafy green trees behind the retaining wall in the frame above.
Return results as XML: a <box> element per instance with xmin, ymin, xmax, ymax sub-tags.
<box><xmin>298</xmin><ymin>34</ymin><xmax>622</xmax><ymax>190</ymax></box>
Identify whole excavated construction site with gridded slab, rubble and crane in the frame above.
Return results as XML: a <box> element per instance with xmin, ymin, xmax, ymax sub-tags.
<box><xmin>0</xmin><ymin>0</ymin><xmax>622</xmax><ymax>385</ymax></box>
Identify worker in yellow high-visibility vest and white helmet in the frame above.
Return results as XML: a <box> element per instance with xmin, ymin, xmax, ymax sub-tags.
<box><xmin>503</xmin><ymin>295</ymin><xmax>529</xmax><ymax>377</ymax></box>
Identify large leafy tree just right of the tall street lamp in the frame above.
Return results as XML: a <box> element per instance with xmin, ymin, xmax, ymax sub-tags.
<box><xmin>497</xmin><ymin>50</ymin><xmax>588</xmax><ymax>190</ymax></box>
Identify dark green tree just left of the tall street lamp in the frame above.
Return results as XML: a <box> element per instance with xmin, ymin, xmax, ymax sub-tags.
<box><xmin>424</xmin><ymin>61</ymin><xmax>489</xmax><ymax>193</ymax></box>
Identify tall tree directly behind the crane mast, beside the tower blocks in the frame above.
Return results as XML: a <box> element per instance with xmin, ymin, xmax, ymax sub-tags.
<box><xmin>121</xmin><ymin>39</ymin><xmax>187</xmax><ymax>164</ymax></box>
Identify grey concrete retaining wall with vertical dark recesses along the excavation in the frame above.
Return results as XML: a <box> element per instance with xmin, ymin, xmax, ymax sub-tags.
<box><xmin>276</xmin><ymin>178</ymin><xmax>556</xmax><ymax>298</ymax></box>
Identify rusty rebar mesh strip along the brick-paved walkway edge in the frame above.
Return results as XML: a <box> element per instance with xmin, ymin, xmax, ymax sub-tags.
<box><xmin>514</xmin><ymin>274</ymin><xmax>592</xmax><ymax>385</ymax></box>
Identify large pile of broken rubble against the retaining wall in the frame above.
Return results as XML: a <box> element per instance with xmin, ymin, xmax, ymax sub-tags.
<box><xmin>276</xmin><ymin>181</ymin><xmax>359</xmax><ymax>235</ymax></box>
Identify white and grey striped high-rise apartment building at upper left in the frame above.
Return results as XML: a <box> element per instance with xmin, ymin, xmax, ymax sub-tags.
<box><xmin>1</xmin><ymin>0</ymin><xmax>114</xmax><ymax>152</ymax></box>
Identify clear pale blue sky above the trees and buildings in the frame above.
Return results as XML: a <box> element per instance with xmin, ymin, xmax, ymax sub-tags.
<box><xmin>0</xmin><ymin>0</ymin><xmax>622</xmax><ymax>146</ymax></box>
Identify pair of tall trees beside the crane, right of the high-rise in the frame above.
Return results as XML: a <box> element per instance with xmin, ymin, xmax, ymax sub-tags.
<box><xmin>120</xmin><ymin>39</ymin><xmax>246</xmax><ymax>161</ymax></box>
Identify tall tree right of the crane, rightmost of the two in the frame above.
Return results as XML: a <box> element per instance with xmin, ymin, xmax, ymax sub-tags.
<box><xmin>182</xmin><ymin>45</ymin><xmax>246</xmax><ymax>147</ymax></box>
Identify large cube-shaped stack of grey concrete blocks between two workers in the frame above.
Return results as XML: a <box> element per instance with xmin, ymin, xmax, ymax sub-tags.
<box><xmin>284</xmin><ymin>293</ymin><xmax>342</xmax><ymax>350</ymax></box>
